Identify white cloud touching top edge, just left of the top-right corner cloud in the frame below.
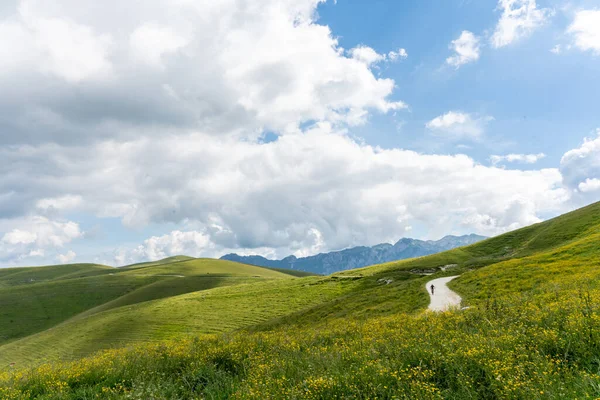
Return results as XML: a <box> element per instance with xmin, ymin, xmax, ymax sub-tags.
<box><xmin>491</xmin><ymin>0</ymin><xmax>554</xmax><ymax>48</ymax></box>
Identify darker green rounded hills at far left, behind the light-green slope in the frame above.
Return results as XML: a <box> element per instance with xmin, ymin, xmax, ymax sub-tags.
<box><xmin>0</xmin><ymin>257</ymin><xmax>292</xmax><ymax>350</ymax></box>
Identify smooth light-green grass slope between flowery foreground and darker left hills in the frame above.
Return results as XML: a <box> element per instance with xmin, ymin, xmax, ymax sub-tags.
<box><xmin>0</xmin><ymin>278</ymin><xmax>352</xmax><ymax>365</ymax></box>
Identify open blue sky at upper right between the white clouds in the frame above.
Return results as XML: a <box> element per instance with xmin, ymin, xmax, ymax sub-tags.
<box><xmin>318</xmin><ymin>0</ymin><xmax>600</xmax><ymax>168</ymax></box>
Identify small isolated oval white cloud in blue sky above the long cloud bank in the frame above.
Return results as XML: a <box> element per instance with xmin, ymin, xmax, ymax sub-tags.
<box><xmin>425</xmin><ymin>111</ymin><xmax>494</xmax><ymax>139</ymax></box>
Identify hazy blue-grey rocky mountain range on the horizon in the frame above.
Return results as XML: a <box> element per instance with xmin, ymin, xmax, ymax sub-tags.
<box><xmin>221</xmin><ymin>234</ymin><xmax>486</xmax><ymax>275</ymax></box>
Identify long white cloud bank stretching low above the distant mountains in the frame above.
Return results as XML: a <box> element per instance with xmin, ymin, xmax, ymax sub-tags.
<box><xmin>0</xmin><ymin>125</ymin><xmax>567</xmax><ymax>266</ymax></box>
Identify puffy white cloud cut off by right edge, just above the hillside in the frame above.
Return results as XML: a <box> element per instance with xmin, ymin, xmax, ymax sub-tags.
<box><xmin>560</xmin><ymin>128</ymin><xmax>600</xmax><ymax>192</ymax></box>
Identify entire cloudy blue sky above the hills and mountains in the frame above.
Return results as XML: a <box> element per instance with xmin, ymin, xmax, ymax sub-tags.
<box><xmin>0</xmin><ymin>0</ymin><xmax>600</xmax><ymax>267</ymax></box>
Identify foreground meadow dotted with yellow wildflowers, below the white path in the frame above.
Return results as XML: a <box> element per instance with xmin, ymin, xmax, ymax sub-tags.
<box><xmin>0</xmin><ymin>280</ymin><xmax>600</xmax><ymax>399</ymax></box>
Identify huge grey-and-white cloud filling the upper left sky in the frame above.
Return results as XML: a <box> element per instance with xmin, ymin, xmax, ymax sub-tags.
<box><xmin>0</xmin><ymin>0</ymin><xmax>406</xmax><ymax>145</ymax></box>
